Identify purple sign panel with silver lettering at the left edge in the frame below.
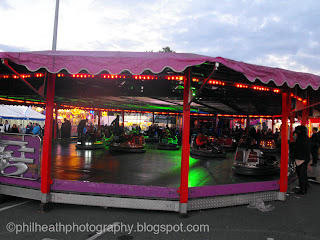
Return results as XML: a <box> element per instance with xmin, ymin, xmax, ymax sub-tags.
<box><xmin>0</xmin><ymin>134</ymin><xmax>41</xmax><ymax>180</ymax></box>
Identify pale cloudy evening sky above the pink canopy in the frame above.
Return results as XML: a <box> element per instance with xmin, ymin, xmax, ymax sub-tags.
<box><xmin>0</xmin><ymin>0</ymin><xmax>320</xmax><ymax>75</ymax></box>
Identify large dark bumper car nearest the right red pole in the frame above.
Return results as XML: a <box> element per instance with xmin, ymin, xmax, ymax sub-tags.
<box><xmin>232</xmin><ymin>142</ymin><xmax>279</xmax><ymax>176</ymax></box>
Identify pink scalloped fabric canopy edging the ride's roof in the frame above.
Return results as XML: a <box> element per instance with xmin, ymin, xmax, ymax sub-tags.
<box><xmin>0</xmin><ymin>51</ymin><xmax>320</xmax><ymax>90</ymax></box>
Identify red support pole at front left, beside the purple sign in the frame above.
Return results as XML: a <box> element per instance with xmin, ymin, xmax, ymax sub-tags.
<box><xmin>41</xmin><ymin>73</ymin><xmax>56</xmax><ymax>193</ymax></box>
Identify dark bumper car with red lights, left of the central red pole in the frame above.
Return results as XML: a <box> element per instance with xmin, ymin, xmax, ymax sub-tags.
<box><xmin>109</xmin><ymin>136</ymin><xmax>146</xmax><ymax>153</ymax></box>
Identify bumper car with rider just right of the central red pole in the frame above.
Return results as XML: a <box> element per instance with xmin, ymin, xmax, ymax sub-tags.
<box><xmin>190</xmin><ymin>134</ymin><xmax>226</xmax><ymax>158</ymax></box>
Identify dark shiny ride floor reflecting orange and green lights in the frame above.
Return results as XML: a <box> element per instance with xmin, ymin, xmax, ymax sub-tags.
<box><xmin>51</xmin><ymin>143</ymin><xmax>279</xmax><ymax>187</ymax></box>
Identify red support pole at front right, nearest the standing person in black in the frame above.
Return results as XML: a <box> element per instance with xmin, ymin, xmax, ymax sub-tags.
<box><xmin>279</xmin><ymin>92</ymin><xmax>290</xmax><ymax>193</ymax></box>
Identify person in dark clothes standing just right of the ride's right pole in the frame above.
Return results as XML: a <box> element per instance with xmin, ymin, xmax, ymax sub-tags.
<box><xmin>293</xmin><ymin>126</ymin><xmax>311</xmax><ymax>194</ymax></box>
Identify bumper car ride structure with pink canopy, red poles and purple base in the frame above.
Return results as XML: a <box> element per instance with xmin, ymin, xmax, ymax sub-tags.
<box><xmin>0</xmin><ymin>51</ymin><xmax>320</xmax><ymax>214</ymax></box>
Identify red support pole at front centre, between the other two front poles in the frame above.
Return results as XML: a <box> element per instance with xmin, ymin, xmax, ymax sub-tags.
<box><xmin>180</xmin><ymin>68</ymin><xmax>191</xmax><ymax>204</ymax></box>
